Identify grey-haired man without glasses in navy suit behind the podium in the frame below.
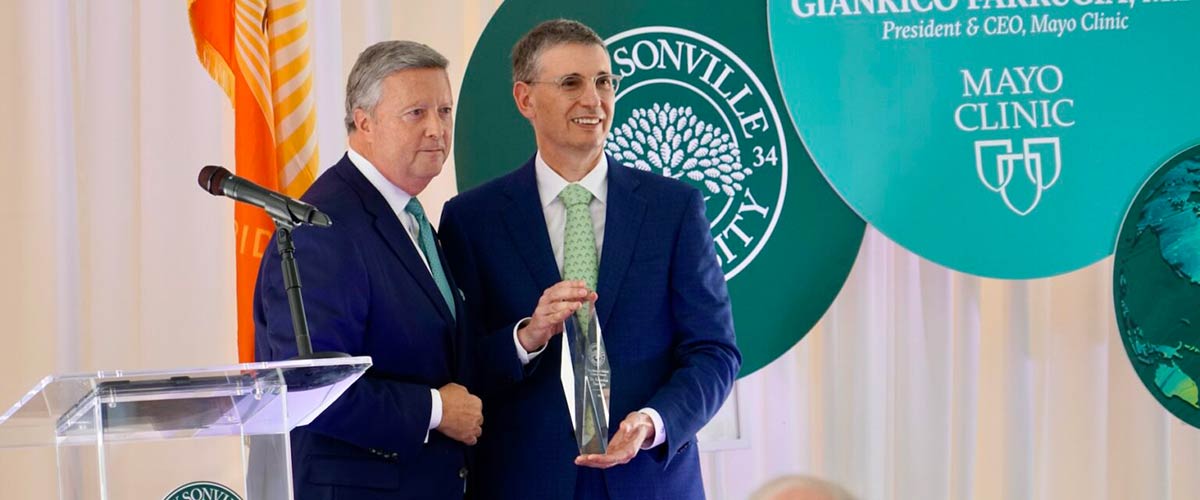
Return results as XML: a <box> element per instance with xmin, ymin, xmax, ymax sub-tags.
<box><xmin>254</xmin><ymin>42</ymin><xmax>482</xmax><ymax>500</ymax></box>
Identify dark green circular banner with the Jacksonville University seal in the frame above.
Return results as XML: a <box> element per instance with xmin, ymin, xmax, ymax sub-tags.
<box><xmin>455</xmin><ymin>0</ymin><xmax>865</xmax><ymax>375</ymax></box>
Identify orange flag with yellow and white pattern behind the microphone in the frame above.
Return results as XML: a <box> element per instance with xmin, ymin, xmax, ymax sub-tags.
<box><xmin>187</xmin><ymin>0</ymin><xmax>317</xmax><ymax>362</ymax></box>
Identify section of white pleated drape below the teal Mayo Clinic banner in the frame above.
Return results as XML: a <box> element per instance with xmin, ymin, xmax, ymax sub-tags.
<box><xmin>703</xmin><ymin>229</ymin><xmax>1200</xmax><ymax>500</ymax></box>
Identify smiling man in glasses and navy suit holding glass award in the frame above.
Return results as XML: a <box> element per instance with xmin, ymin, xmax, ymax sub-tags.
<box><xmin>440</xmin><ymin>19</ymin><xmax>742</xmax><ymax>500</ymax></box>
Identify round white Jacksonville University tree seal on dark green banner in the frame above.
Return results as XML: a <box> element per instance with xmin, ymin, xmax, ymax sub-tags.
<box><xmin>605</xmin><ymin>26</ymin><xmax>787</xmax><ymax>279</ymax></box>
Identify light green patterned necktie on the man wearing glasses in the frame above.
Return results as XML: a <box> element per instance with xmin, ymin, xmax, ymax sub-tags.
<box><xmin>558</xmin><ymin>182</ymin><xmax>596</xmax><ymax>323</ymax></box>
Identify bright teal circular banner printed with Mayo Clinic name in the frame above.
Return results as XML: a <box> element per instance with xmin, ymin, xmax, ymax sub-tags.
<box><xmin>768</xmin><ymin>0</ymin><xmax>1200</xmax><ymax>278</ymax></box>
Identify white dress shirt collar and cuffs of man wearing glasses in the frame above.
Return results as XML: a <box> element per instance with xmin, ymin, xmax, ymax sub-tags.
<box><xmin>512</xmin><ymin>151</ymin><xmax>667</xmax><ymax>450</ymax></box>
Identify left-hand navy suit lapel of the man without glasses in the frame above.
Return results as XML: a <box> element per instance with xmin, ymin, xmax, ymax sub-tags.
<box><xmin>334</xmin><ymin>157</ymin><xmax>454</xmax><ymax>325</ymax></box>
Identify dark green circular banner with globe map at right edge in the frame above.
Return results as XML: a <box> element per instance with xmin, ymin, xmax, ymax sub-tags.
<box><xmin>1112</xmin><ymin>146</ymin><xmax>1200</xmax><ymax>427</ymax></box>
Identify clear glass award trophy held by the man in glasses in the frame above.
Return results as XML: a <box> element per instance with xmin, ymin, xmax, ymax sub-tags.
<box><xmin>563</xmin><ymin>302</ymin><xmax>611</xmax><ymax>454</ymax></box>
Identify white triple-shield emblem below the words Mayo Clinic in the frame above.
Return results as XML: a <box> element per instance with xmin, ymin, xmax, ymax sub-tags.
<box><xmin>976</xmin><ymin>137</ymin><xmax>1062</xmax><ymax>216</ymax></box>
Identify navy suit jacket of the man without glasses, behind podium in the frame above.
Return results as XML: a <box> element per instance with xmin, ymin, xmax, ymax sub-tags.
<box><xmin>254</xmin><ymin>156</ymin><xmax>469</xmax><ymax>500</ymax></box>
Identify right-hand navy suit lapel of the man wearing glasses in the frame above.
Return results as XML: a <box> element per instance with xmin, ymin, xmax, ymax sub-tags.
<box><xmin>596</xmin><ymin>157</ymin><xmax>646</xmax><ymax>325</ymax></box>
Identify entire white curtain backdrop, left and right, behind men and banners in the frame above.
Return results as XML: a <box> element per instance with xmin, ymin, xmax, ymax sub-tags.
<box><xmin>0</xmin><ymin>0</ymin><xmax>1200</xmax><ymax>500</ymax></box>
